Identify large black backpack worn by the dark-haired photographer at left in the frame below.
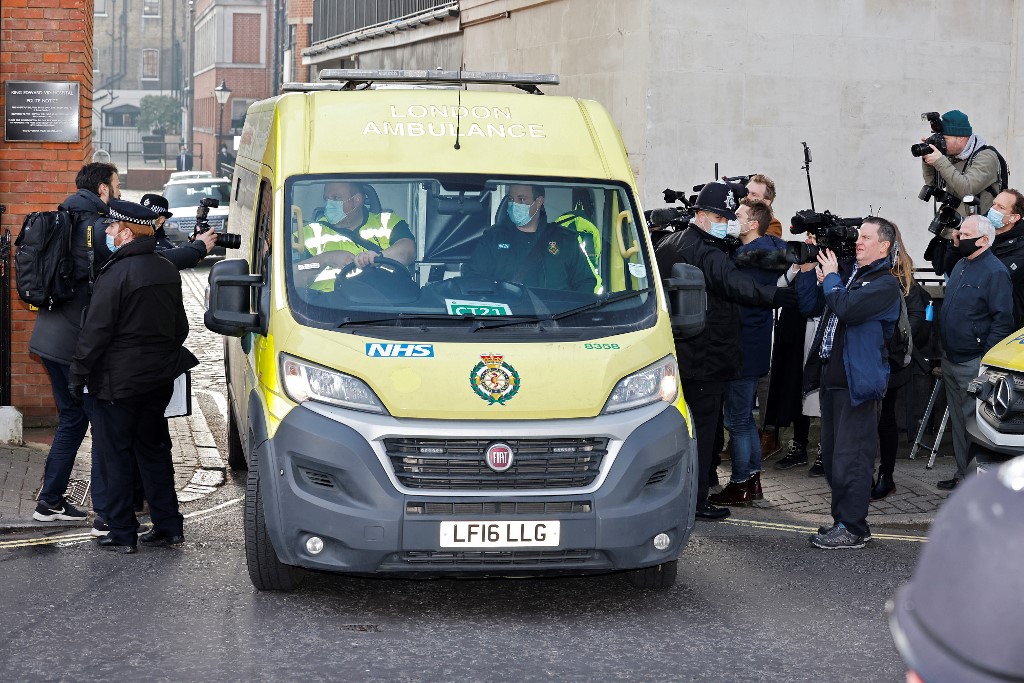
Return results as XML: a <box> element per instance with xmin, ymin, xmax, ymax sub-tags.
<box><xmin>14</xmin><ymin>209</ymin><xmax>93</xmax><ymax>309</ymax></box>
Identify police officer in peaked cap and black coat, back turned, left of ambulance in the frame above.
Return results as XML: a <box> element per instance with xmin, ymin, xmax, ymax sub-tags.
<box><xmin>68</xmin><ymin>200</ymin><xmax>199</xmax><ymax>553</ymax></box>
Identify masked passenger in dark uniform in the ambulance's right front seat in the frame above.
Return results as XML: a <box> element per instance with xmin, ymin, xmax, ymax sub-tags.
<box><xmin>467</xmin><ymin>184</ymin><xmax>597</xmax><ymax>294</ymax></box>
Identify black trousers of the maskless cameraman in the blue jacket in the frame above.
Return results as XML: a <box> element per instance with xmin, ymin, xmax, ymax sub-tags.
<box><xmin>819</xmin><ymin>388</ymin><xmax>882</xmax><ymax>536</ymax></box>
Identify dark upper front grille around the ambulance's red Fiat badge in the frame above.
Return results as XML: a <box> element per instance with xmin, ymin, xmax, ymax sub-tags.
<box><xmin>384</xmin><ymin>438</ymin><xmax>608</xmax><ymax>490</ymax></box>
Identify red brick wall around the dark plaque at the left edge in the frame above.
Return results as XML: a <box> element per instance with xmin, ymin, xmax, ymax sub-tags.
<box><xmin>0</xmin><ymin>0</ymin><xmax>92</xmax><ymax>425</ymax></box>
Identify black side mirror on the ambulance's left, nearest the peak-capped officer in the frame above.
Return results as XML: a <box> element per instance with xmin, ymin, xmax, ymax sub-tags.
<box><xmin>203</xmin><ymin>258</ymin><xmax>266</xmax><ymax>337</ymax></box>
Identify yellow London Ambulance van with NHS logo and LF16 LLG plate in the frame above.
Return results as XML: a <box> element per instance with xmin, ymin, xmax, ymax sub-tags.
<box><xmin>206</xmin><ymin>70</ymin><xmax>703</xmax><ymax>590</ymax></box>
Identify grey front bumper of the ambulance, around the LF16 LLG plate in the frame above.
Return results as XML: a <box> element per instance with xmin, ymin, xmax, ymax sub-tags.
<box><xmin>253</xmin><ymin>405</ymin><xmax>697</xmax><ymax>577</ymax></box>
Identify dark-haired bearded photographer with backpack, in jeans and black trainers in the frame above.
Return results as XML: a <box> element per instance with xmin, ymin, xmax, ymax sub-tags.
<box><xmin>29</xmin><ymin>163</ymin><xmax>121</xmax><ymax>533</ymax></box>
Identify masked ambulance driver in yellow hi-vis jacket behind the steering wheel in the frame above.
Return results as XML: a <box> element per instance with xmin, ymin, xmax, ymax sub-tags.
<box><xmin>295</xmin><ymin>182</ymin><xmax>416</xmax><ymax>292</ymax></box>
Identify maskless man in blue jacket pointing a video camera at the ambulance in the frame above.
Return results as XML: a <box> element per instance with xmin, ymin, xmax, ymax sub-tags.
<box><xmin>797</xmin><ymin>216</ymin><xmax>902</xmax><ymax>550</ymax></box>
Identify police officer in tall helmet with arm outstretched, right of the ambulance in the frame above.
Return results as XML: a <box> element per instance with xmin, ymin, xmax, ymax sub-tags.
<box><xmin>654</xmin><ymin>182</ymin><xmax>797</xmax><ymax>519</ymax></box>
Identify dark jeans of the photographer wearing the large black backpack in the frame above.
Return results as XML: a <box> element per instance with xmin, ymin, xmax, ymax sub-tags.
<box><xmin>39</xmin><ymin>358</ymin><xmax>106</xmax><ymax>516</ymax></box>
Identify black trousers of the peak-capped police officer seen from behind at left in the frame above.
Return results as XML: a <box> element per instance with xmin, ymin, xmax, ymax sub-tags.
<box><xmin>92</xmin><ymin>384</ymin><xmax>183</xmax><ymax>546</ymax></box>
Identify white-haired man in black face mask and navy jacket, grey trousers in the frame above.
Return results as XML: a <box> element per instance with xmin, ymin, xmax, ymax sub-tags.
<box><xmin>938</xmin><ymin>216</ymin><xmax>1014</xmax><ymax>490</ymax></box>
